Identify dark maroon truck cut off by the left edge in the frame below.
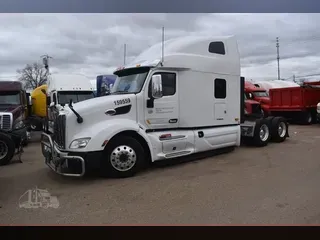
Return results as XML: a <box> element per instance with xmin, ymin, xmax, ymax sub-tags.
<box><xmin>0</xmin><ymin>81</ymin><xmax>30</xmax><ymax>165</ymax></box>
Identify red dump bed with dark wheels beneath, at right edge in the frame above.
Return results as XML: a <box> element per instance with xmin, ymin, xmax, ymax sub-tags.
<box><xmin>269</xmin><ymin>83</ymin><xmax>320</xmax><ymax>124</ymax></box>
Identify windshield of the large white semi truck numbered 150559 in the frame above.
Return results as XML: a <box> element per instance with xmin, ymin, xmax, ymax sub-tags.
<box><xmin>110</xmin><ymin>67</ymin><xmax>150</xmax><ymax>94</ymax></box>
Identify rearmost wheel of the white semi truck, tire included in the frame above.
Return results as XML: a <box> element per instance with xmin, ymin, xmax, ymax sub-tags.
<box><xmin>271</xmin><ymin>117</ymin><xmax>288</xmax><ymax>143</ymax></box>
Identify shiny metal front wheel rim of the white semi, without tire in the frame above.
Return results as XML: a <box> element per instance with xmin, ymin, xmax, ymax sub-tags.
<box><xmin>110</xmin><ymin>145</ymin><xmax>137</xmax><ymax>172</ymax></box>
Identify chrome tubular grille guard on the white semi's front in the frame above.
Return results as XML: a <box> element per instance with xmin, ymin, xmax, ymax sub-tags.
<box><xmin>41</xmin><ymin>133</ymin><xmax>85</xmax><ymax>177</ymax></box>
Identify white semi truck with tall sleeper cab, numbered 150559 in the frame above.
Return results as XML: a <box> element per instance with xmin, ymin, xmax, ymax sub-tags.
<box><xmin>41</xmin><ymin>36</ymin><xmax>288</xmax><ymax>177</ymax></box>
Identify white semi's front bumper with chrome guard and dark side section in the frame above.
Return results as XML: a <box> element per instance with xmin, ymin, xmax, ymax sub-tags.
<box><xmin>41</xmin><ymin>133</ymin><xmax>102</xmax><ymax>177</ymax></box>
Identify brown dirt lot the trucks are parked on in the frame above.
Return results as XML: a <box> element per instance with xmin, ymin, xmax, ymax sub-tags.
<box><xmin>0</xmin><ymin>125</ymin><xmax>320</xmax><ymax>224</ymax></box>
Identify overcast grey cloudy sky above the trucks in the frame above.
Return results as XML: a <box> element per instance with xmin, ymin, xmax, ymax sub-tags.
<box><xmin>0</xmin><ymin>13</ymin><xmax>320</xmax><ymax>84</ymax></box>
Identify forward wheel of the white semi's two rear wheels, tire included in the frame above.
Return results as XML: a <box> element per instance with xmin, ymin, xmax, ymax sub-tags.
<box><xmin>252</xmin><ymin>119</ymin><xmax>270</xmax><ymax>147</ymax></box>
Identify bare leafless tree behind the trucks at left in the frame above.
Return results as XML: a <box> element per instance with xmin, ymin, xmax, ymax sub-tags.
<box><xmin>17</xmin><ymin>62</ymin><xmax>47</xmax><ymax>89</ymax></box>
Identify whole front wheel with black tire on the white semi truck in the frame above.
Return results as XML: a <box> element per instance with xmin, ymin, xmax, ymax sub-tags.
<box><xmin>100</xmin><ymin>136</ymin><xmax>145</xmax><ymax>178</ymax></box>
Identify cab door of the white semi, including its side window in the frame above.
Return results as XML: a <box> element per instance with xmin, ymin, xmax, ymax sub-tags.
<box><xmin>145</xmin><ymin>71</ymin><xmax>179</xmax><ymax>129</ymax></box>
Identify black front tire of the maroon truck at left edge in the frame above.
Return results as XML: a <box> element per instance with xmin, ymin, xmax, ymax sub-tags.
<box><xmin>0</xmin><ymin>133</ymin><xmax>15</xmax><ymax>166</ymax></box>
